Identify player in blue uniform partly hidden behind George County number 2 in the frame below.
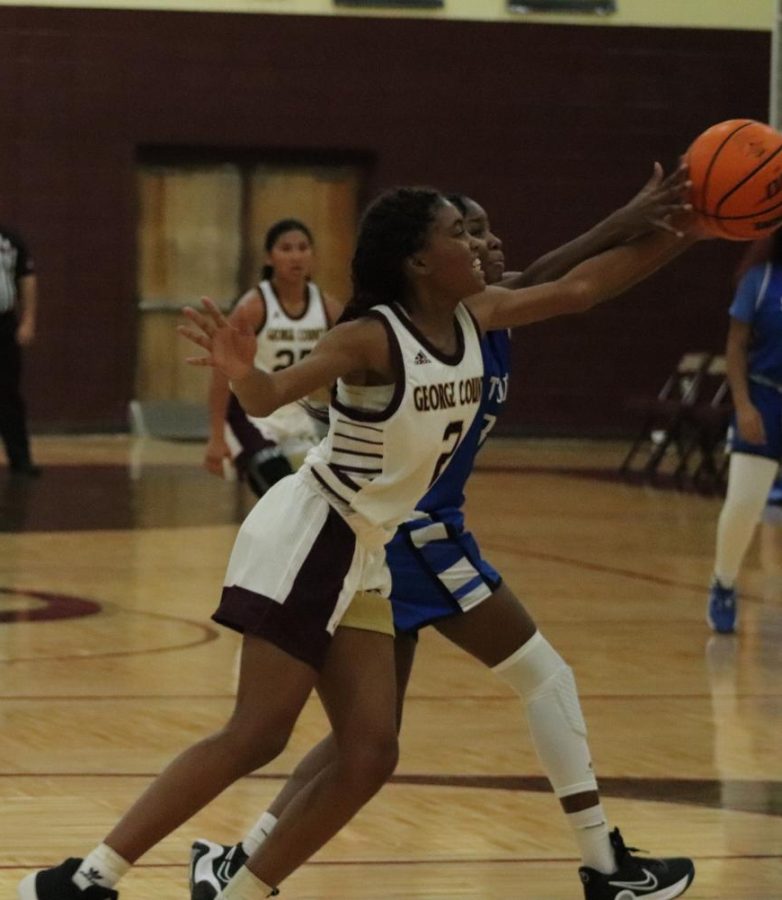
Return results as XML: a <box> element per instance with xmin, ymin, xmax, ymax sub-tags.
<box><xmin>190</xmin><ymin>172</ymin><xmax>693</xmax><ymax>900</ymax></box>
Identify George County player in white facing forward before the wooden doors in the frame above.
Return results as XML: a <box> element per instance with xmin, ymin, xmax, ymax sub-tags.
<box><xmin>204</xmin><ymin>219</ymin><xmax>341</xmax><ymax>496</ymax></box>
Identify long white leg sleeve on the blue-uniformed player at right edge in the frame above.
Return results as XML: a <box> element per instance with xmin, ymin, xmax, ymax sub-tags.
<box><xmin>714</xmin><ymin>453</ymin><xmax>779</xmax><ymax>587</ymax></box>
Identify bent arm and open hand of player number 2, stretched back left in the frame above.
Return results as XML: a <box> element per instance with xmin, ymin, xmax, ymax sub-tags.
<box><xmin>177</xmin><ymin>298</ymin><xmax>395</xmax><ymax>417</ymax></box>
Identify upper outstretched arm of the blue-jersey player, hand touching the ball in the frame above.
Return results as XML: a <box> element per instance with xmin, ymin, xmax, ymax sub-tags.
<box><xmin>501</xmin><ymin>163</ymin><xmax>691</xmax><ymax>289</ymax></box>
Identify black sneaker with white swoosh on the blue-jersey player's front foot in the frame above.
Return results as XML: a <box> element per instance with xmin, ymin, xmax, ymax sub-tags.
<box><xmin>578</xmin><ymin>828</ymin><xmax>695</xmax><ymax>900</ymax></box>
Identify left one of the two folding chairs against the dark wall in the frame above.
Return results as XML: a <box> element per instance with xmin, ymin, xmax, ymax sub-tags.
<box><xmin>619</xmin><ymin>353</ymin><xmax>711</xmax><ymax>479</ymax></box>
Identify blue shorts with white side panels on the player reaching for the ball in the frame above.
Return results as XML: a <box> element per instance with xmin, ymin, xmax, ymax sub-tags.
<box><xmin>386</xmin><ymin>515</ymin><xmax>502</xmax><ymax>634</ymax></box>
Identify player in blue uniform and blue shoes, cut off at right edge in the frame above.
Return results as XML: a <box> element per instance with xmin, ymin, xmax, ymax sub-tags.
<box><xmin>707</xmin><ymin>231</ymin><xmax>782</xmax><ymax>634</ymax></box>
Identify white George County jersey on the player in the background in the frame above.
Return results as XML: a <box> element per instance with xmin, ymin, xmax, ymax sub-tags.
<box><xmin>250</xmin><ymin>281</ymin><xmax>329</xmax><ymax>443</ymax></box>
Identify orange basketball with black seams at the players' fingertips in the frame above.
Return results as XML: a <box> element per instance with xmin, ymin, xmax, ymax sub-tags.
<box><xmin>685</xmin><ymin>119</ymin><xmax>782</xmax><ymax>241</ymax></box>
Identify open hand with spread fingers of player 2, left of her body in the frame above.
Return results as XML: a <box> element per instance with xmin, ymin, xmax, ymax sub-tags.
<box><xmin>177</xmin><ymin>297</ymin><xmax>258</xmax><ymax>381</ymax></box>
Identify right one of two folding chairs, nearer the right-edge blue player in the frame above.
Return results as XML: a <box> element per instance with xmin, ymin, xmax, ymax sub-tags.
<box><xmin>676</xmin><ymin>356</ymin><xmax>733</xmax><ymax>490</ymax></box>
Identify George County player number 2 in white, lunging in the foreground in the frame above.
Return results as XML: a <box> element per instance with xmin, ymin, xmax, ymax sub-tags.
<box><xmin>19</xmin><ymin>188</ymin><xmax>694</xmax><ymax>900</ymax></box>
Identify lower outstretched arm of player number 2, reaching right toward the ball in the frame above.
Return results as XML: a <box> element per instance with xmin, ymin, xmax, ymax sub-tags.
<box><xmin>465</xmin><ymin>232</ymin><xmax>698</xmax><ymax>331</ymax></box>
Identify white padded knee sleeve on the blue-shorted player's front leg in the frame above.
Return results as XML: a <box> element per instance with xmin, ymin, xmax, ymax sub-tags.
<box><xmin>493</xmin><ymin>632</ymin><xmax>597</xmax><ymax>798</ymax></box>
